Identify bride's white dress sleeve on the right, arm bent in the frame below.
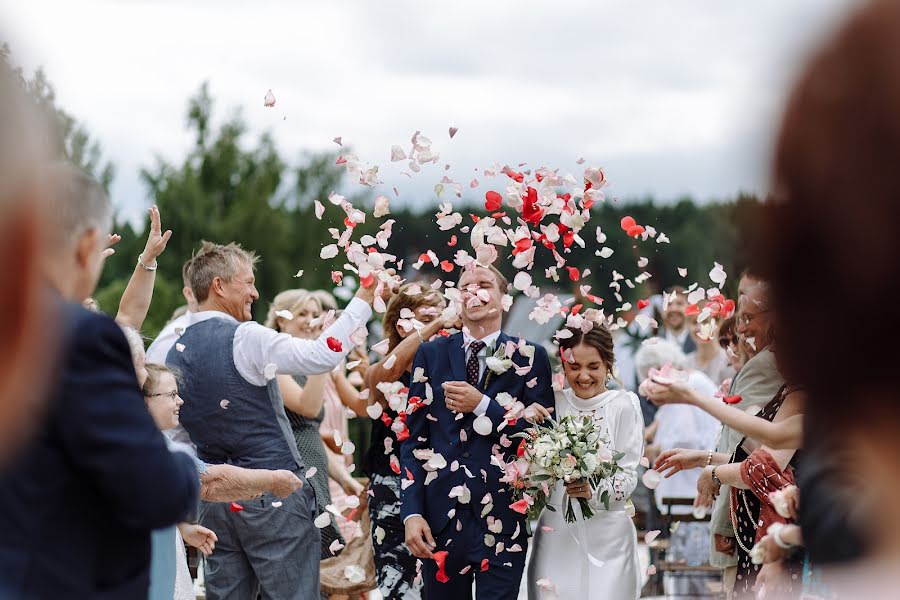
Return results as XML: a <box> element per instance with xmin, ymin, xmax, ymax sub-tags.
<box><xmin>592</xmin><ymin>392</ymin><xmax>644</xmax><ymax>508</ymax></box>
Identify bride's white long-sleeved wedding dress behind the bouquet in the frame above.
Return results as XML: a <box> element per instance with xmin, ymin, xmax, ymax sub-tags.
<box><xmin>528</xmin><ymin>388</ymin><xmax>644</xmax><ymax>600</ymax></box>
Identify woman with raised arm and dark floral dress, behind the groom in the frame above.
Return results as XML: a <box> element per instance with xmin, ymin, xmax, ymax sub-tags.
<box><xmin>365</xmin><ymin>283</ymin><xmax>454</xmax><ymax>600</ymax></box>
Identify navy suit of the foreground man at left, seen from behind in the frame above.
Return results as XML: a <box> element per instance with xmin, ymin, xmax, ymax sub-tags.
<box><xmin>0</xmin><ymin>305</ymin><xmax>199</xmax><ymax>599</ymax></box>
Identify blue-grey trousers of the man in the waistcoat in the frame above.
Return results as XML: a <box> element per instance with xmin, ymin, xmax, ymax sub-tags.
<box><xmin>200</xmin><ymin>483</ymin><xmax>321</xmax><ymax>600</ymax></box>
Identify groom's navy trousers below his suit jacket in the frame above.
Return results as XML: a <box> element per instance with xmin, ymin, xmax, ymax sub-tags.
<box><xmin>422</xmin><ymin>504</ymin><xmax>528</xmax><ymax>600</ymax></box>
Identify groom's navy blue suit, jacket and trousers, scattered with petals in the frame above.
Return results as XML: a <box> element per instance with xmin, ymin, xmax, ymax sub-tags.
<box><xmin>400</xmin><ymin>333</ymin><xmax>554</xmax><ymax>600</ymax></box>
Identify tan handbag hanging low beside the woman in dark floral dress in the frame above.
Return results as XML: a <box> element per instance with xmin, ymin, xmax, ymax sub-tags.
<box><xmin>319</xmin><ymin>486</ymin><xmax>378</xmax><ymax>596</ymax></box>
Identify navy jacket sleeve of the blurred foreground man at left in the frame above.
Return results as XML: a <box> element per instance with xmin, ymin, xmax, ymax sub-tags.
<box><xmin>60</xmin><ymin>315</ymin><xmax>199</xmax><ymax>529</ymax></box>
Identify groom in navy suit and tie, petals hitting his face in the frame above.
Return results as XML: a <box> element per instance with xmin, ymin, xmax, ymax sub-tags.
<box><xmin>400</xmin><ymin>266</ymin><xmax>554</xmax><ymax>600</ymax></box>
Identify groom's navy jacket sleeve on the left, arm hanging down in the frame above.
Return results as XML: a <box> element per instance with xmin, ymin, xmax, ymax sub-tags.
<box><xmin>400</xmin><ymin>345</ymin><xmax>431</xmax><ymax>520</ymax></box>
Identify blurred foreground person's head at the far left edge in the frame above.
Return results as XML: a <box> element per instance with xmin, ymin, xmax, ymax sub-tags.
<box><xmin>0</xmin><ymin>56</ymin><xmax>57</xmax><ymax>464</ymax></box>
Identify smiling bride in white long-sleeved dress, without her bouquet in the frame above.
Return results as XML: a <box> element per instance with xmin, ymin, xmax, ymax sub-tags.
<box><xmin>528</xmin><ymin>323</ymin><xmax>644</xmax><ymax>600</ymax></box>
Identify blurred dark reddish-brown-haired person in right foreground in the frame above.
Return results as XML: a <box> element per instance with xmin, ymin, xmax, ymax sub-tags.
<box><xmin>763</xmin><ymin>1</ymin><xmax>900</xmax><ymax>599</ymax></box>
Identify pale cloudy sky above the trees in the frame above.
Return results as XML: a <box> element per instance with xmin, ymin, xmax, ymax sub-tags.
<box><xmin>0</xmin><ymin>0</ymin><xmax>858</xmax><ymax>225</ymax></box>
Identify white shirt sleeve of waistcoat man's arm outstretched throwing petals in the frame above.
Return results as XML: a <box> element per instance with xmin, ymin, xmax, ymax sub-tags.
<box><xmin>234</xmin><ymin>298</ymin><xmax>372</xmax><ymax>386</ymax></box>
